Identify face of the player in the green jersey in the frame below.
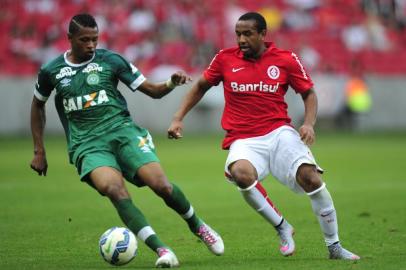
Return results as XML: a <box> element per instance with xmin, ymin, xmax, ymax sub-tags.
<box><xmin>68</xmin><ymin>27</ymin><xmax>99</xmax><ymax>62</ymax></box>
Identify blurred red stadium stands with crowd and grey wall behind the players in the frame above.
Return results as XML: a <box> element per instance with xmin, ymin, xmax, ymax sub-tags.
<box><xmin>0</xmin><ymin>0</ymin><xmax>406</xmax><ymax>135</ymax></box>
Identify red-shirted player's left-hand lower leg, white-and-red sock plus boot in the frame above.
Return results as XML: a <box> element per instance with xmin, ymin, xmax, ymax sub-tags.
<box><xmin>238</xmin><ymin>181</ymin><xmax>295</xmax><ymax>256</ymax></box>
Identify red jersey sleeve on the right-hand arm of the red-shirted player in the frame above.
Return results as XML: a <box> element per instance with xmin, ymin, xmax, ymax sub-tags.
<box><xmin>288</xmin><ymin>53</ymin><xmax>313</xmax><ymax>93</ymax></box>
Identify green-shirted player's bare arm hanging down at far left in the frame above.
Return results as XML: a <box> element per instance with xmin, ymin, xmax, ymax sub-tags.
<box><xmin>31</xmin><ymin>97</ymin><xmax>48</xmax><ymax>176</ymax></box>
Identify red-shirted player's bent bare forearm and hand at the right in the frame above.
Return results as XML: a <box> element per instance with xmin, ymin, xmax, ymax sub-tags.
<box><xmin>299</xmin><ymin>88</ymin><xmax>317</xmax><ymax>145</ymax></box>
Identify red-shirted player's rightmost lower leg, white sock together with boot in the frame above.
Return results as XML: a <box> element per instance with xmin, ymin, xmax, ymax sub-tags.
<box><xmin>307</xmin><ymin>183</ymin><xmax>360</xmax><ymax>260</ymax></box>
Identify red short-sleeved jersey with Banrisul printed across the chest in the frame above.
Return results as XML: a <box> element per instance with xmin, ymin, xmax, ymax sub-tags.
<box><xmin>203</xmin><ymin>43</ymin><xmax>313</xmax><ymax>149</ymax></box>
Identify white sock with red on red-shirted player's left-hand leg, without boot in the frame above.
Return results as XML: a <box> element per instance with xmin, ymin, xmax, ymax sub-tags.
<box><xmin>238</xmin><ymin>181</ymin><xmax>283</xmax><ymax>227</ymax></box>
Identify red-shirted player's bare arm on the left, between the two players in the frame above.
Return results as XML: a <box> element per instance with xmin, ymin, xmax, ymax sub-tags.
<box><xmin>168</xmin><ymin>76</ymin><xmax>211</xmax><ymax>139</ymax></box>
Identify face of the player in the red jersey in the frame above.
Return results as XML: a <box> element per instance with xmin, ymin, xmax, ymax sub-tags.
<box><xmin>235</xmin><ymin>20</ymin><xmax>266</xmax><ymax>58</ymax></box>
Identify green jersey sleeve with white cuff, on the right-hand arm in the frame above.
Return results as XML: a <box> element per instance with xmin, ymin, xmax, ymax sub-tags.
<box><xmin>109</xmin><ymin>54</ymin><xmax>146</xmax><ymax>91</ymax></box>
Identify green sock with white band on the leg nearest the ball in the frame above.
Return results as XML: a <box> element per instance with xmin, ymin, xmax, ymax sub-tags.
<box><xmin>113</xmin><ymin>199</ymin><xmax>168</xmax><ymax>252</ymax></box>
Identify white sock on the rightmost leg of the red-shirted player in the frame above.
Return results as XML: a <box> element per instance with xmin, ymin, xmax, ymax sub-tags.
<box><xmin>307</xmin><ymin>183</ymin><xmax>339</xmax><ymax>246</ymax></box>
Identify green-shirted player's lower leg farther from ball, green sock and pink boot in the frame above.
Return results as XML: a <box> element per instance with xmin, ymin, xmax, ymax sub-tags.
<box><xmin>163</xmin><ymin>183</ymin><xmax>224</xmax><ymax>255</ymax></box>
